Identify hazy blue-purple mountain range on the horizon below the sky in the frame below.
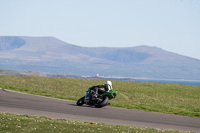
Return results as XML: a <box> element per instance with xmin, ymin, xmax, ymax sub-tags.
<box><xmin>0</xmin><ymin>36</ymin><xmax>200</xmax><ymax>80</ymax></box>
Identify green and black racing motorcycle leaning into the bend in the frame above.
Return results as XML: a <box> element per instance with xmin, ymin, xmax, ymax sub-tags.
<box><xmin>76</xmin><ymin>89</ymin><xmax>117</xmax><ymax>108</ymax></box>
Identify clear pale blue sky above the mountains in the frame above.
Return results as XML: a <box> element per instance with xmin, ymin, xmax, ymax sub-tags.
<box><xmin>0</xmin><ymin>0</ymin><xmax>200</xmax><ymax>59</ymax></box>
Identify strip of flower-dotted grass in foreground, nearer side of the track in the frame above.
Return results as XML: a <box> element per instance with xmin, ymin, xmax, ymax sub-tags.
<box><xmin>0</xmin><ymin>113</ymin><xmax>194</xmax><ymax>133</ymax></box>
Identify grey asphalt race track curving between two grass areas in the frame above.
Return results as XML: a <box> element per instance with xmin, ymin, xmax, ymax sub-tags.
<box><xmin>0</xmin><ymin>88</ymin><xmax>200</xmax><ymax>132</ymax></box>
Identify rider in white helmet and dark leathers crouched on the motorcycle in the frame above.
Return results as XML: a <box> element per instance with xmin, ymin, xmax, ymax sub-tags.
<box><xmin>85</xmin><ymin>81</ymin><xmax>113</xmax><ymax>102</ymax></box>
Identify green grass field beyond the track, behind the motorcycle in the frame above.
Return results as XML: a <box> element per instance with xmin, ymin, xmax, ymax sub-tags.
<box><xmin>0</xmin><ymin>76</ymin><xmax>200</xmax><ymax>117</ymax></box>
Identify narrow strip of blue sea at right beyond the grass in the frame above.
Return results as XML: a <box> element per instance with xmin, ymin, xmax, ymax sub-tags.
<box><xmin>135</xmin><ymin>79</ymin><xmax>200</xmax><ymax>86</ymax></box>
